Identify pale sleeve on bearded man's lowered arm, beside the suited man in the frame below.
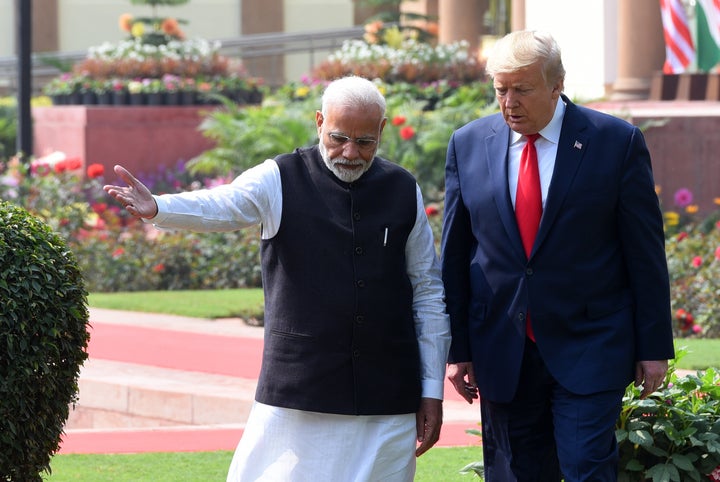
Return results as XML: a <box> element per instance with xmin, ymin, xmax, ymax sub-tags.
<box><xmin>405</xmin><ymin>186</ymin><xmax>450</xmax><ymax>400</ymax></box>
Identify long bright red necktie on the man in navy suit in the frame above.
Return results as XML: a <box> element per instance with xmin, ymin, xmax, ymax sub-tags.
<box><xmin>515</xmin><ymin>134</ymin><xmax>542</xmax><ymax>341</ymax></box>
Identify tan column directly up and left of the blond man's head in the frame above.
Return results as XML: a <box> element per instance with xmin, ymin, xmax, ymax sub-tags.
<box><xmin>438</xmin><ymin>0</ymin><xmax>487</xmax><ymax>52</ymax></box>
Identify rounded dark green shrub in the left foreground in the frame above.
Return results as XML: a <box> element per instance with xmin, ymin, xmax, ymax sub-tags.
<box><xmin>0</xmin><ymin>201</ymin><xmax>89</xmax><ymax>482</ymax></box>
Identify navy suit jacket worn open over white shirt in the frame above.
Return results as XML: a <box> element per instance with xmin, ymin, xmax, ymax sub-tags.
<box><xmin>442</xmin><ymin>96</ymin><xmax>674</xmax><ymax>402</ymax></box>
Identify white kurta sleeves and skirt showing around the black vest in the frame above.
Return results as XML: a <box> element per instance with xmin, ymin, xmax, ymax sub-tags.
<box><xmin>151</xmin><ymin>160</ymin><xmax>450</xmax><ymax>482</ymax></box>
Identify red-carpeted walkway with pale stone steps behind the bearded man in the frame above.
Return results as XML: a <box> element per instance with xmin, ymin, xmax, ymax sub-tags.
<box><xmin>59</xmin><ymin>309</ymin><xmax>479</xmax><ymax>454</ymax></box>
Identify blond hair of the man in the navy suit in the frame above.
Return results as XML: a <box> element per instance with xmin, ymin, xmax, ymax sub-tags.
<box><xmin>485</xmin><ymin>30</ymin><xmax>565</xmax><ymax>85</ymax></box>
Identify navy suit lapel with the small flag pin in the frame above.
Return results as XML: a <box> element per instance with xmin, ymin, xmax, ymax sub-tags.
<box><xmin>531</xmin><ymin>96</ymin><xmax>590</xmax><ymax>256</ymax></box>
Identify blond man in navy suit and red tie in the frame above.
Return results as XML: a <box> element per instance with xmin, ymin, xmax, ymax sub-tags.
<box><xmin>442</xmin><ymin>31</ymin><xmax>674</xmax><ymax>482</ymax></box>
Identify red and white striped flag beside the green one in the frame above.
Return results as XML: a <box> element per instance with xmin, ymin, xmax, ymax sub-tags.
<box><xmin>660</xmin><ymin>0</ymin><xmax>695</xmax><ymax>74</ymax></box>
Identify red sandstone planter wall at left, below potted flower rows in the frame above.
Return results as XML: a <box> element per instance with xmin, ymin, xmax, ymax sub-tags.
<box><xmin>32</xmin><ymin>105</ymin><xmax>213</xmax><ymax>180</ymax></box>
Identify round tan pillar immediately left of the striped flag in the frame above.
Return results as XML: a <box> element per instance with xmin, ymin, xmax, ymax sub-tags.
<box><xmin>611</xmin><ymin>0</ymin><xmax>665</xmax><ymax>100</ymax></box>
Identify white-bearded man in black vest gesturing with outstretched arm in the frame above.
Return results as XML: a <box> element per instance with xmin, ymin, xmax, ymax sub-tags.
<box><xmin>105</xmin><ymin>77</ymin><xmax>450</xmax><ymax>482</ymax></box>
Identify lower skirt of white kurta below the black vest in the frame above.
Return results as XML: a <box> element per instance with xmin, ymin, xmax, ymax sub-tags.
<box><xmin>227</xmin><ymin>402</ymin><xmax>416</xmax><ymax>482</ymax></box>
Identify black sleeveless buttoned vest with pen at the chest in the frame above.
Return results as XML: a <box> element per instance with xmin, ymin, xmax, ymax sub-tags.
<box><xmin>256</xmin><ymin>146</ymin><xmax>421</xmax><ymax>415</ymax></box>
